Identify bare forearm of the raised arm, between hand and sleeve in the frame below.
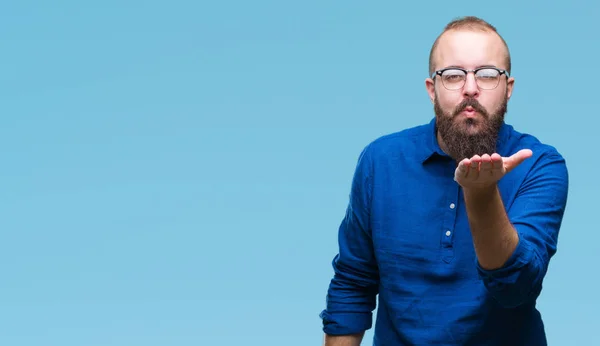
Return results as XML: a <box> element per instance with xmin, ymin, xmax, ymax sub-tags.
<box><xmin>464</xmin><ymin>184</ymin><xmax>519</xmax><ymax>270</ymax></box>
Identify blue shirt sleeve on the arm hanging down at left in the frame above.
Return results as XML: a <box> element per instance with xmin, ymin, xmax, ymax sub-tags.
<box><xmin>320</xmin><ymin>143</ymin><xmax>379</xmax><ymax>335</ymax></box>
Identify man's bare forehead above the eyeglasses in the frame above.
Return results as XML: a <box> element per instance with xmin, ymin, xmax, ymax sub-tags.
<box><xmin>436</xmin><ymin>30</ymin><xmax>508</xmax><ymax>69</ymax></box>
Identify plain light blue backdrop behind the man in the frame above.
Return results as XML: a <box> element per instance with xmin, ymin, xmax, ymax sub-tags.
<box><xmin>0</xmin><ymin>0</ymin><xmax>600</xmax><ymax>346</ymax></box>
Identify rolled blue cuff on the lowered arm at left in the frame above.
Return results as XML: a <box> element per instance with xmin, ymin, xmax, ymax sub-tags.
<box><xmin>319</xmin><ymin>310</ymin><xmax>373</xmax><ymax>335</ymax></box>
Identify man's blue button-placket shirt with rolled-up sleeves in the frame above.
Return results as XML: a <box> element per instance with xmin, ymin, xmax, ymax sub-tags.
<box><xmin>320</xmin><ymin>119</ymin><xmax>568</xmax><ymax>346</ymax></box>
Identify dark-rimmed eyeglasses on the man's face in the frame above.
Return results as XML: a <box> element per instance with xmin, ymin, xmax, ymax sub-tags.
<box><xmin>431</xmin><ymin>67</ymin><xmax>509</xmax><ymax>90</ymax></box>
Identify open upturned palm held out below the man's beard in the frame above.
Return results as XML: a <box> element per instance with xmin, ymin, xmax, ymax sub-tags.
<box><xmin>454</xmin><ymin>149</ymin><xmax>533</xmax><ymax>188</ymax></box>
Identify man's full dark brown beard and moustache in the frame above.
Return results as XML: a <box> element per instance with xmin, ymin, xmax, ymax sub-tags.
<box><xmin>434</xmin><ymin>95</ymin><xmax>508</xmax><ymax>162</ymax></box>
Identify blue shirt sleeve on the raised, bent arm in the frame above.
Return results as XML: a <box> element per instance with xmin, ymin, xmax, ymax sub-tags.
<box><xmin>477</xmin><ymin>150</ymin><xmax>568</xmax><ymax>308</ymax></box>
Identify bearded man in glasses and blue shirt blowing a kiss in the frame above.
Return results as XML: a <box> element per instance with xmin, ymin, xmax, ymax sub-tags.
<box><xmin>321</xmin><ymin>17</ymin><xmax>568</xmax><ymax>346</ymax></box>
